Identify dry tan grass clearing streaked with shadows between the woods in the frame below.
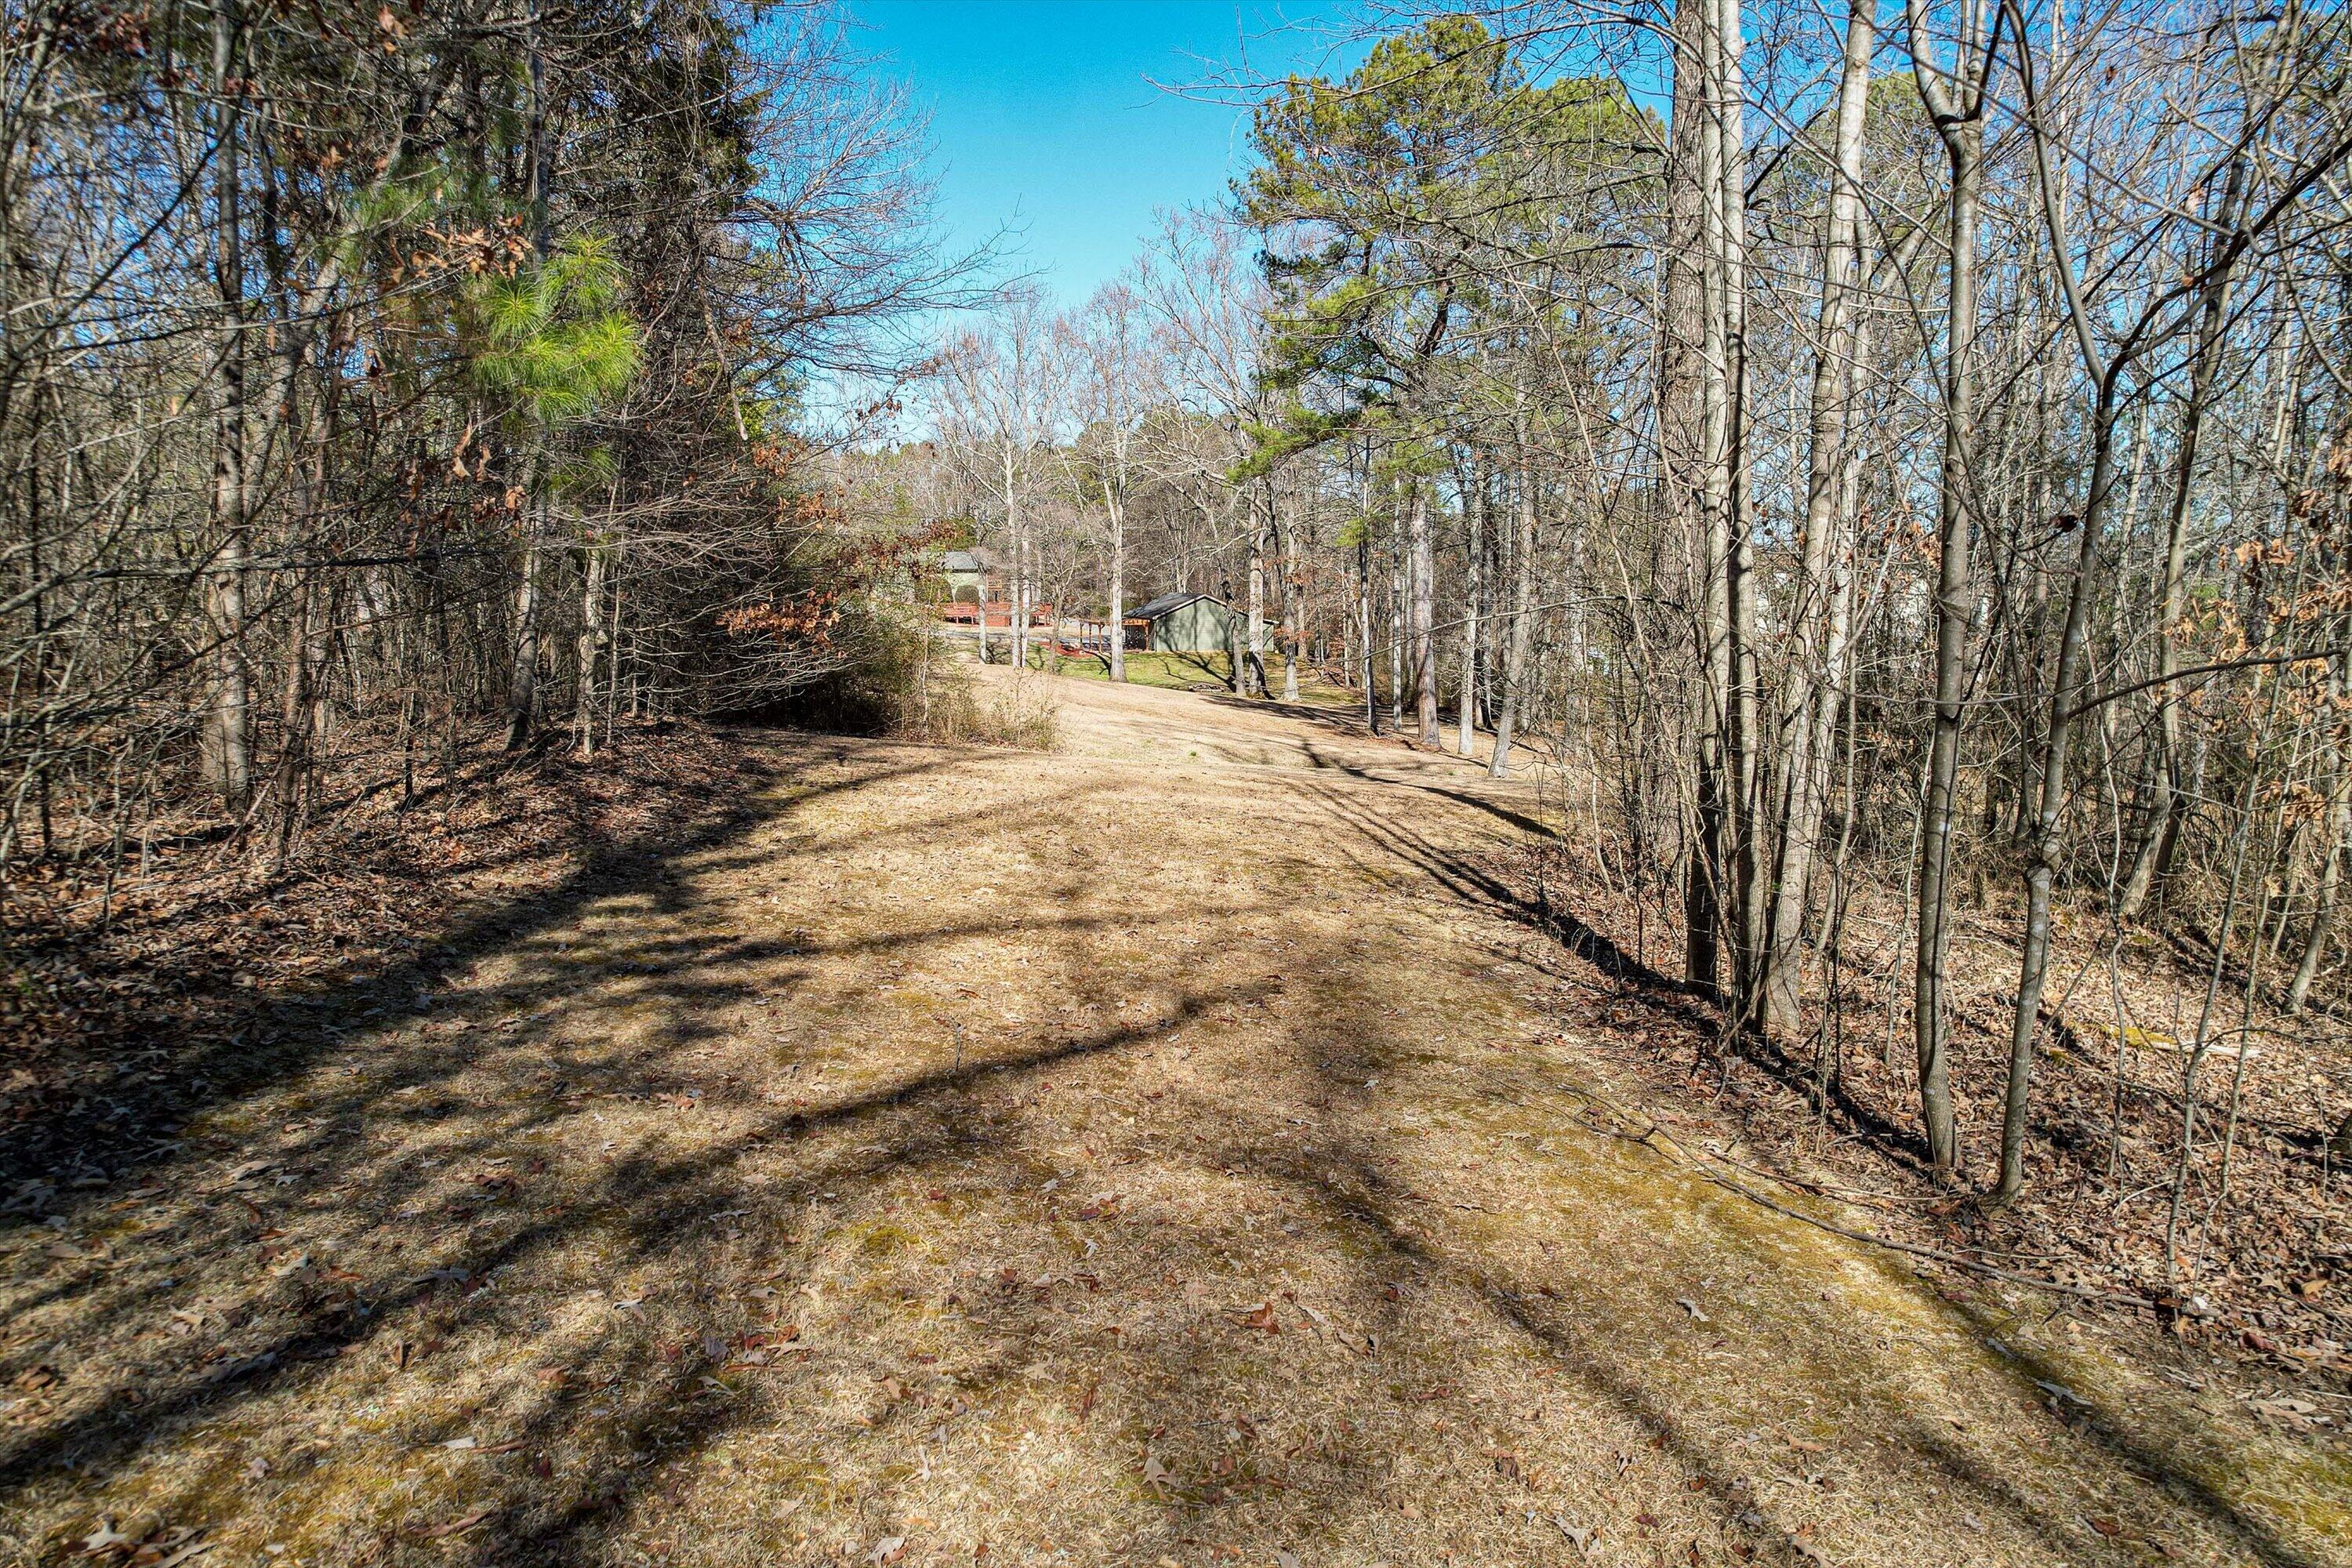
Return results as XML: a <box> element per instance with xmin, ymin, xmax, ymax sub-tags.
<box><xmin>0</xmin><ymin>677</ymin><xmax>2352</xmax><ymax>1568</ymax></box>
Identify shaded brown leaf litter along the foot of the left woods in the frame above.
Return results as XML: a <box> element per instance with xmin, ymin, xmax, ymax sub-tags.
<box><xmin>0</xmin><ymin>722</ymin><xmax>748</xmax><ymax>1213</ymax></box>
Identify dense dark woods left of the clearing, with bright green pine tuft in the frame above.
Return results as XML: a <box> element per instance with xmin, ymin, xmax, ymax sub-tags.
<box><xmin>0</xmin><ymin>0</ymin><xmax>960</xmax><ymax>862</ymax></box>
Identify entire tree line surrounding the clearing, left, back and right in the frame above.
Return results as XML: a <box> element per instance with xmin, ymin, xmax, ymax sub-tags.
<box><xmin>18</xmin><ymin>0</ymin><xmax>2352</xmax><ymax>1192</ymax></box>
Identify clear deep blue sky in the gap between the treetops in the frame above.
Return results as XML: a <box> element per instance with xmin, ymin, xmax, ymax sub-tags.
<box><xmin>851</xmin><ymin>0</ymin><xmax>1329</xmax><ymax>306</ymax></box>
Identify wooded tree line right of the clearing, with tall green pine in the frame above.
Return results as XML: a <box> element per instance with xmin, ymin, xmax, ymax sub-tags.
<box><xmin>922</xmin><ymin>0</ymin><xmax>2352</xmax><ymax>1194</ymax></box>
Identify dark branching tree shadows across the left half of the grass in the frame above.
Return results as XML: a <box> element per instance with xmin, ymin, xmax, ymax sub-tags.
<box><xmin>0</xmin><ymin>742</ymin><xmax>1308</xmax><ymax>1561</ymax></box>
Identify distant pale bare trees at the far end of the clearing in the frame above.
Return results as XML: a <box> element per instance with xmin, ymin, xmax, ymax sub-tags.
<box><xmin>898</xmin><ymin>212</ymin><xmax>1345</xmax><ymax>699</ymax></box>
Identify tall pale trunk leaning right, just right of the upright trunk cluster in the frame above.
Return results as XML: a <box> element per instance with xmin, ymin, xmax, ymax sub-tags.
<box><xmin>1764</xmin><ymin>0</ymin><xmax>1877</xmax><ymax>1039</ymax></box>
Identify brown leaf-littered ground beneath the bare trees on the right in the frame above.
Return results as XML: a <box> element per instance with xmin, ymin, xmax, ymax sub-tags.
<box><xmin>1494</xmin><ymin>839</ymin><xmax>2352</xmax><ymax>1425</ymax></box>
